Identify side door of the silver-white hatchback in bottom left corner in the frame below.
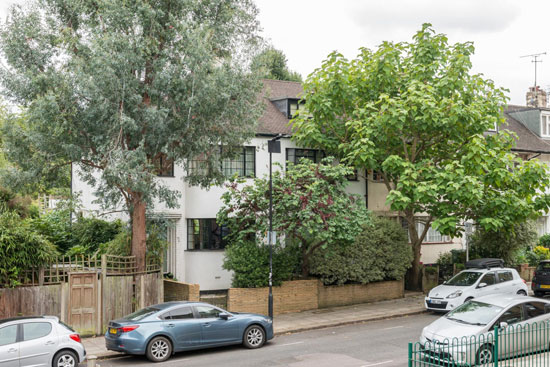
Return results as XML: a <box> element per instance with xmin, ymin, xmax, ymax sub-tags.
<box><xmin>19</xmin><ymin>321</ymin><xmax>58</xmax><ymax>367</ymax></box>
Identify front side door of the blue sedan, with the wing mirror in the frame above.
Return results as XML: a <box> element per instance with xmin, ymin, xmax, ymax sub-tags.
<box><xmin>195</xmin><ymin>306</ymin><xmax>242</xmax><ymax>345</ymax></box>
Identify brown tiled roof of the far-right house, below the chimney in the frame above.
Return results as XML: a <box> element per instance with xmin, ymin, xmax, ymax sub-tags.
<box><xmin>501</xmin><ymin>105</ymin><xmax>550</xmax><ymax>154</ymax></box>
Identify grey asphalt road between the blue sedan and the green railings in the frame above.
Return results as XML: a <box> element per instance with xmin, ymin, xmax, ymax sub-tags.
<box><xmin>94</xmin><ymin>314</ymin><xmax>439</xmax><ymax>367</ymax></box>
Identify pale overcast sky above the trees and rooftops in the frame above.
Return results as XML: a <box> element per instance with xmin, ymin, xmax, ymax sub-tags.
<box><xmin>0</xmin><ymin>0</ymin><xmax>550</xmax><ymax>105</ymax></box>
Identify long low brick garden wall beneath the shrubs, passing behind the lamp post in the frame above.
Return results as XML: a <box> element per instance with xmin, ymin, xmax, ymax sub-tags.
<box><xmin>227</xmin><ymin>280</ymin><xmax>405</xmax><ymax>315</ymax></box>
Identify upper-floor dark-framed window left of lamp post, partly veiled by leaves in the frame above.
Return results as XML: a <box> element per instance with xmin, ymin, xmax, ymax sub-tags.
<box><xmin>187</xmin><ymin>146</ymin><xmax>256</xmax><ymax>177</ymax></box>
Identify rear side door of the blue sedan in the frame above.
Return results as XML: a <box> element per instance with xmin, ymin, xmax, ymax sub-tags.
<box><xmin>164</xmin><ymin>306</ymin><xmax>205</xmax><ymax>351</ymax></box>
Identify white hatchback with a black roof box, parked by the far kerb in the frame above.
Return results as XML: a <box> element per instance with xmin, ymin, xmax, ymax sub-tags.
<box><xmin>425</xmin><ymin>259</ymin><xmax>529</xmax><ymax>312</ymax></box>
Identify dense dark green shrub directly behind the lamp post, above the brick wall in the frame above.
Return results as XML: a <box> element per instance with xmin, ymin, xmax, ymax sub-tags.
<box><xmin>223</xmin><ymin>241</ymin><xmax>300</xmax><ymax>288</ymax></box>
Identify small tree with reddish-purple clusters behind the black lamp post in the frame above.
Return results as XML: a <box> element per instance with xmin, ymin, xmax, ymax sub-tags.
<box><xmin>218</xmin><ymin>158</ymin><xmax>369</xmax><ymax>276</ymax></box>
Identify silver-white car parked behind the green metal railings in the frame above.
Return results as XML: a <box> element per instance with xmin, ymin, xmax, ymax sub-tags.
<box><xmin>420</xmin><ymin>295</ymin><xmax>550</xmax><ymax>366</ymax></box>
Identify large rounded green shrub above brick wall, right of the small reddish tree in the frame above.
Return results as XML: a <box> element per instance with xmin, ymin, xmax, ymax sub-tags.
<box><xmin>310</xmin><ymin>217</ymin><xmax>412</xmax><ymax>285</ymax></box>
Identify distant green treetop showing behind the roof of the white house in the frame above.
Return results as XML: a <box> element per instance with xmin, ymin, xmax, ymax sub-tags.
<box><xmin>250</xmin><ymin>47</ymin><xmax>302</xmax><ymax>82</ymax></box>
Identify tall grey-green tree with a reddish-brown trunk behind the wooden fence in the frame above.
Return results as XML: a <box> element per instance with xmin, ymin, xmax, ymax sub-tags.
<box><xmin>0</xmin><ymin>0</ymin><xmax>266</xmax><ymax>270</ymax></box>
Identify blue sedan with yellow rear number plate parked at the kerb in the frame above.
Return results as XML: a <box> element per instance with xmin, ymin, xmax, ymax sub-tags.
<box><xmin>105</xmin><ymin>302</ymin><xmax>273</xmax><ymax>362</ymax></box>
